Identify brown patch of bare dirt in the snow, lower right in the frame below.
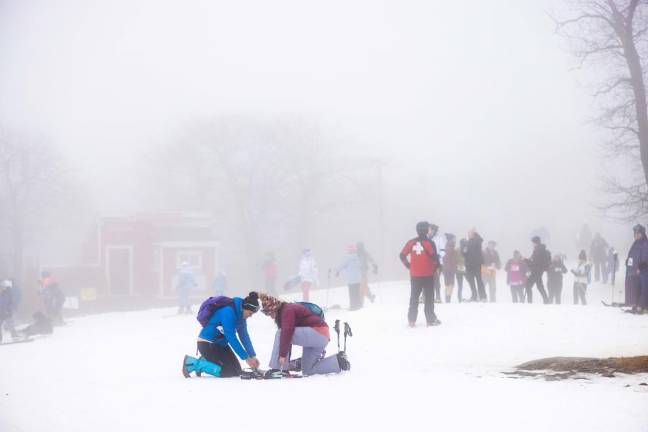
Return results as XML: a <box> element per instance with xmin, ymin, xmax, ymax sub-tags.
<box><xmin>505</xmin><ymin>356</ymin><xmax>648</xmax><ymax>381</ymax></box>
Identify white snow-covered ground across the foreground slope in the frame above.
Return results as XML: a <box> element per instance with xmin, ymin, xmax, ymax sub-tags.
<box><xmin>0</xmin><ymin>282</ymin><xmax>648</xmax><ymax>432</ymax></box>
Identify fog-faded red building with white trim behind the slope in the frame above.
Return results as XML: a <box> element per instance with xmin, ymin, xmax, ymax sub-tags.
<box><xmin>43</xmin><ymin>214</ymin><xmax>221</xmax><ymax>300</ymax></box>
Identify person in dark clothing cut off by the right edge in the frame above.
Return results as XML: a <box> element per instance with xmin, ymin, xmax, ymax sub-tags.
<box><xmin>625</xmin><ymin>224</ymin><xmax>648</xmax><ymax>313</ymax></box>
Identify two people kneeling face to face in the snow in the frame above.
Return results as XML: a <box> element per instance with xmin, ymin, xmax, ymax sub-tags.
<box><xmin>182</xmin><ymin>292</ymin><xmax>351</xmax><ymax>378</ymax></box>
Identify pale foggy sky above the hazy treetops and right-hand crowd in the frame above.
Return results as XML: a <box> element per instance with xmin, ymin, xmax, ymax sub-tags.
<box><xmin>0</xmin><ymin>0</ymin><xmax>629</xmax><ymax>264</ymax></box>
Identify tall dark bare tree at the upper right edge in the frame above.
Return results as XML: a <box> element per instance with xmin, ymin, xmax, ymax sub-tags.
<box><xmin>555</xmin><ymin>0</ymin><xmax>648</xmax><ymax>220</ymax></box>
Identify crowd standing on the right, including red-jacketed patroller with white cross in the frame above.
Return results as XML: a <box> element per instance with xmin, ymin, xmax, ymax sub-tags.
<box><xmin>400</xmin><ymin>222</ymin><xmax>648</xmax><ymax>326</ymax></box>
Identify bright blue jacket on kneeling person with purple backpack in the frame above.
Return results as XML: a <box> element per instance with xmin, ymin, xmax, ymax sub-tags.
<box><xmin>198</xmin><ymin>297</ymin><xmax>256</xmax><ymax>360</ymax></box>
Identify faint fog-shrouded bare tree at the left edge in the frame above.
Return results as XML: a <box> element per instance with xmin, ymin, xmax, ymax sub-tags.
<box><xmin>0</xmin><ymin>130</ymin><xmax>71</xmax><ymax>283</ymax></box>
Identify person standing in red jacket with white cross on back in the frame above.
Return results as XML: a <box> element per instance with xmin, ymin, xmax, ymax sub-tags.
<box><xmin>400</xmin><ymin>222</ymin><xmax>441</xmax><ymax>327</ymax></box>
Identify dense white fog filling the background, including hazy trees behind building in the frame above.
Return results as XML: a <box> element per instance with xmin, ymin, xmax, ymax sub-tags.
<box><xmin>0</xmin><ymin>0</ymin><xmax>632</xmax><ymax>291</ymax></box>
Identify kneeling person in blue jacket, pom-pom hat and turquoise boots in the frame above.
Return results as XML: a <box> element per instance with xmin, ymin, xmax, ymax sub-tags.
<box><xmin>182</xmin><ymin>291</ymin><xmax>259</xmax><ymax>378</ymax></box>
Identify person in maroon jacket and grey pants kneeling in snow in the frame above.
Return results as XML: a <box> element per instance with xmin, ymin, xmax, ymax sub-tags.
<box><xmin>260</xmin><ymin>293</ymin><xmax>351</xmax><ymax>375</ymax></box>
